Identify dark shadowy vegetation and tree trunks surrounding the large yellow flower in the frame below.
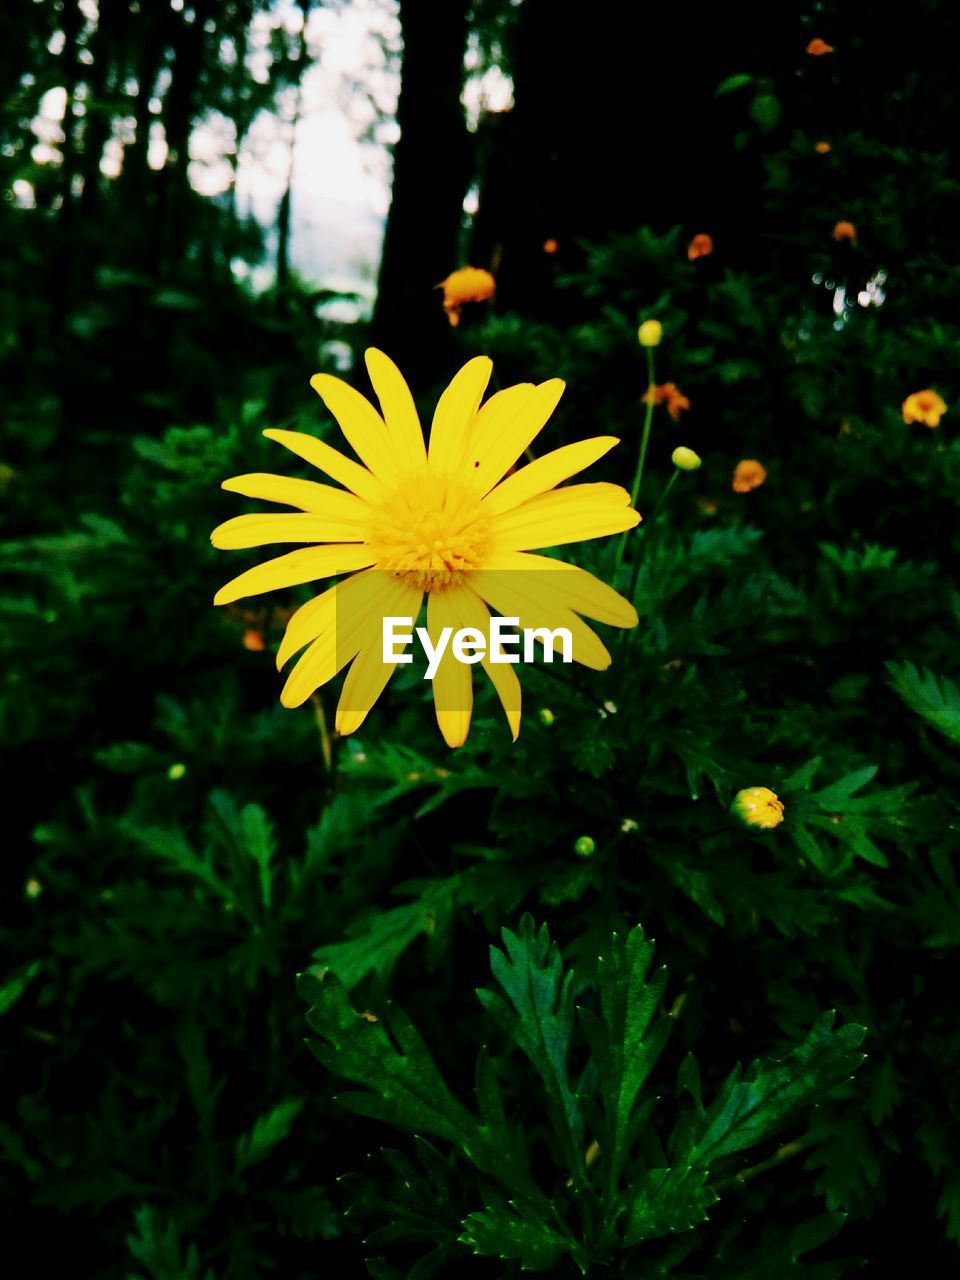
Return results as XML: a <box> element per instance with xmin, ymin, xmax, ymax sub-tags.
<box><xmin>0</xmin><ymin>0</ymin><xmax>960</xmax><ymax>1280</ymax></box>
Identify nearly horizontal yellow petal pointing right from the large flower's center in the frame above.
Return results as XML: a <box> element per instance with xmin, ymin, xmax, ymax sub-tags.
<box><xmin>490</xmin><ymin>484</ymin><xmax>640</xmax><ymax>550</ymax></box>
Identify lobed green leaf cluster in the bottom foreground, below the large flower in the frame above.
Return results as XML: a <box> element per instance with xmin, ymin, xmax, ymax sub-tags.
<box><xmin>301</xmin><ymin>915</ymin><xmax>863</xmax><ymax>1276</ymax></box>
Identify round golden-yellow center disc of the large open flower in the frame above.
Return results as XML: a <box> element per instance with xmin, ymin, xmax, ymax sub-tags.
<box><xmin>366</xmin><ymin>471</ymin><xmax>490</xmax><ymax>591</ymax></box>
